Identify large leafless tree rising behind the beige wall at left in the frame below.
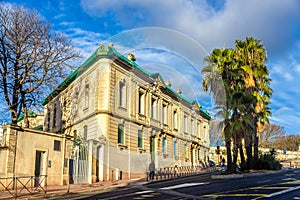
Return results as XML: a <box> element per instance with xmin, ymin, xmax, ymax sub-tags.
<box><xmin>0</xmin><ymin>4</ymin><xmax>79</xmax><ymax>126</ymax></box>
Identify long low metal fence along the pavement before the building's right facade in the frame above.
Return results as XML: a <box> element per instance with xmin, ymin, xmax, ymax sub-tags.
<box><xmin>147</xmin><ymin>165</ymin><xmax>216</xmax><ymax>181</ymax></box>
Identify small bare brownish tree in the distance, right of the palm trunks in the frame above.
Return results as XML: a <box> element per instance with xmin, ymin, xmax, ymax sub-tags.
<box><xmin>259</xmin><ymin>124</ymin><xmax>285</xmax><ymax>148</ymax></box>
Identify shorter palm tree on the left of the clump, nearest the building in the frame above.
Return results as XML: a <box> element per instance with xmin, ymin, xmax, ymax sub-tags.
<box><xmin>202</xmin><ymin>49</ymin><xmax>238</xmax><ymax>171</ymax></box>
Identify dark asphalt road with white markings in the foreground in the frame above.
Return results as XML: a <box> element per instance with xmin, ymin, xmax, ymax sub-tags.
<box><xmin>76</xmin><ymin>169</ymin><xmax>300</xmax><ymax>200</ymax></box>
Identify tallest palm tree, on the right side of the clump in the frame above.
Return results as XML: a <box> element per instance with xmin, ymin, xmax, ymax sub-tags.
<box><xmin>235</xmin><ymin>37</ymin><xmax>272</xmax><ymax>168</ymax></box>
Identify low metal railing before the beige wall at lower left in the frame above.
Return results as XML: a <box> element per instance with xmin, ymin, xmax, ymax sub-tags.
<box><xmin>0</xmin><ymin>175</ymin><xmax>47</xmax><ymax>199</ymax></box>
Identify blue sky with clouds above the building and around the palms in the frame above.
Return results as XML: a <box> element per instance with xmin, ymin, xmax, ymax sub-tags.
<box><xmin>1</xmin><ymin>0</ymin><xmax>300</xmax><ymax>134</ymax></box>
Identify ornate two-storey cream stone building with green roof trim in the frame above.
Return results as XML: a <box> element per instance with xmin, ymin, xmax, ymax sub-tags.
<box><xmin>43</xmin><ymin>45</ymin><xmax>210</xmax><ymax>183</ymax></box>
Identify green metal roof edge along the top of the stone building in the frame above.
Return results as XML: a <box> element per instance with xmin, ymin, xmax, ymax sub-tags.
<box><xmin>42</xmin><ymin>45</ymin><xmax>211</xmax><ymax>119</ymax></box>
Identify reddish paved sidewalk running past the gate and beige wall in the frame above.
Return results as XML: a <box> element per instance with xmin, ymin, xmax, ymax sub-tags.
<box><xmin>0</xmin><ymin>179</ymin><xmax>146</xmax><ymax>200</ymax></box>
